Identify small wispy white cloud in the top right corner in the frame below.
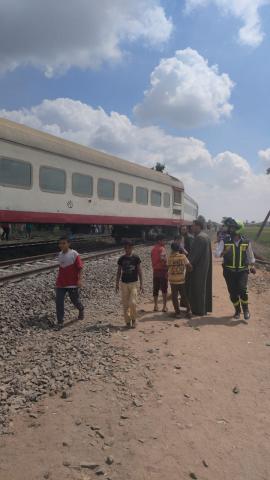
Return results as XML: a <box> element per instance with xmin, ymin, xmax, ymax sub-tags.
<box><xmin>186</xmin><ymin>0</ymin><xmax>270</xmax><ymax>47</ymax></box>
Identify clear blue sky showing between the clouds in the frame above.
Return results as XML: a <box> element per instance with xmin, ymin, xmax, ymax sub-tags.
<box><xmin>0</xmin><ymin>0</ymin><xmax>270</xmax><ymax>217</ymax></box>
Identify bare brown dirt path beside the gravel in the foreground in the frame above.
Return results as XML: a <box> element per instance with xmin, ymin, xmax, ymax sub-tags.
<box><xmin>0</xmin><ymin>261</ymin><xmax>270</xmax><ymax>480</ymax></box>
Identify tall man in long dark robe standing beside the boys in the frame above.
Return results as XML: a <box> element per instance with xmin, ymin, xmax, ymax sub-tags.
<box><xmin>188</xmin><ymin>220</ymin><xmax>212</xmax><ymax>316</ymax></box>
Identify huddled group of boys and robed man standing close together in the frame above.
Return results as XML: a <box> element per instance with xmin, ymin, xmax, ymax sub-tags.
<box><xmin>151</xmin><ymin>220</ymin><xmax>212</xmax><ymax>318</ymax></box>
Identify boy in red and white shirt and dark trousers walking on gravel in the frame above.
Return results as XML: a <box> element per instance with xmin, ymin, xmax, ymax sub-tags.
<box><xmin>56</xmin><ymin>237</ymin><xmax>84</xmax><ymax>329</ymax></box>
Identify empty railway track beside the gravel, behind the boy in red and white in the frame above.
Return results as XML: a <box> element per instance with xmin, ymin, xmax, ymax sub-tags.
<box><xmin>0</xmin><ymin>247</ymin><xmax>123</xmax><ymax>287</ymax></box>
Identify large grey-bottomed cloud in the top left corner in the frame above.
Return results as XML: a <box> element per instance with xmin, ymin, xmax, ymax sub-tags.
<box><xmin>0</xmin><ymin>0</ymin><xmax>172</xmax><ymax>77</ymax></box>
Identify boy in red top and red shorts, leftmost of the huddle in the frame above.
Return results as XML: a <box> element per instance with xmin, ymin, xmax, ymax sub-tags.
<box><xmin>151</xmin><ymin>235</ymin><xmax>168</xmax><ymax>312</ymax></box>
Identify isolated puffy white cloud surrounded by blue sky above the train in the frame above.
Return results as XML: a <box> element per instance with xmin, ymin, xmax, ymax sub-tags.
<box><xmin>134</xmin><ymin>48</ymin><xmax>234</xmax><ymax>128</ymax></box>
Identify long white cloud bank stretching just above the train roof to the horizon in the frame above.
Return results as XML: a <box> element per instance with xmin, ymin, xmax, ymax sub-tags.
<box><xmin>0</xmin><ymin>98</ymin><xmax>269</xmax><ymax>220</ymax></box>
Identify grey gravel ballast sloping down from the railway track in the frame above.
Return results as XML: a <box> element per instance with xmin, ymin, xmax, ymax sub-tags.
<box><xmin>0</xmin><ymin>247</ymin><xmax>155</xmax><ymax>433</ymax></box>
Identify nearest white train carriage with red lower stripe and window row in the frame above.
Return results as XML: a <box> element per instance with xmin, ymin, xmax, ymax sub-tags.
<box><xmin>0</xmin><ymin>119</ymin><xmax>195</xmax><ymax>232</ymax></box>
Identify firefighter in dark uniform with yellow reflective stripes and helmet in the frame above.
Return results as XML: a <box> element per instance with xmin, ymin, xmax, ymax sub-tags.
<box><xmin>216</xmin><ymin>218</ymin><xmax>256</xmax><ymax>320</ymax></box>
